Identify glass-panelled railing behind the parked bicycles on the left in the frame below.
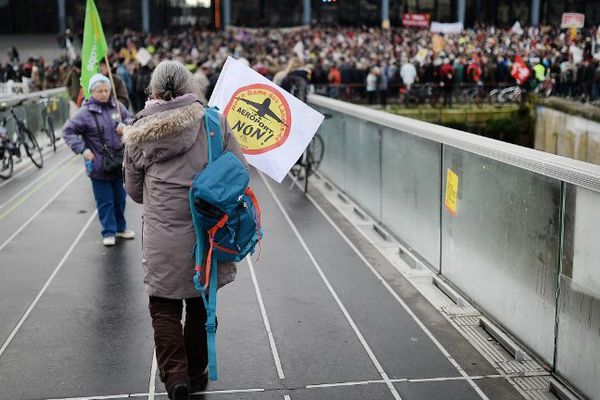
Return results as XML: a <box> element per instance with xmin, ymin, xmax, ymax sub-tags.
<box><xmin>0</xmin><ymin>88</ymin><xmax>70</xmax><ymax>144</ymax></box>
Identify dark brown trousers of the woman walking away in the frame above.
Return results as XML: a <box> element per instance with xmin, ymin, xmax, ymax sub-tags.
<box><xmin>148</xmin><ymin>296</ymin><xmax>208</xmax><ymax>392</ymax></box>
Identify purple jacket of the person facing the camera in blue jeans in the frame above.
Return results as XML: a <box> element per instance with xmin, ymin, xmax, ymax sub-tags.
<box><xmin>62</xmin><ymin>97</ymin><xmax>133</xmax><ymax>180</ymax></box>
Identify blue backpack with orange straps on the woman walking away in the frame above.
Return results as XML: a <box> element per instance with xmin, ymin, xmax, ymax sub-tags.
<box><xmin>190</xmin><ymin>108</ymin><xmax>263</xmax><ymax>381</ymax></box>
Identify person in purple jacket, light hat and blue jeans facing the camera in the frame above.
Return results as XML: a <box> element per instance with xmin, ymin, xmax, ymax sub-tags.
<box><xmin>63</xmin><ymin>74</ymin><xmax>135</xmax><ymax>246</ymax></box>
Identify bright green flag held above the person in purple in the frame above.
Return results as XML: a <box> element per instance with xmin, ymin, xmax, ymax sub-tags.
<box><xmin>79</xmin><ymin>0</ymin><xmax>108</xmax><ymax>99</ymax></box>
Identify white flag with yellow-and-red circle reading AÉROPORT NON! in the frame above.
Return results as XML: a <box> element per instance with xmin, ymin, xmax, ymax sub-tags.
<box><xmin>208</xmin><ymin>57</ymin><xmax>324</xmax><ymax>183</ymax></box>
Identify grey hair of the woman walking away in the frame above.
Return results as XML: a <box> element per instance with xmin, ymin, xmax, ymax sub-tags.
<box><xmin>148</xmin><ymin>60</ymin><xmax>202</xmax><ymax>100</ymax></box>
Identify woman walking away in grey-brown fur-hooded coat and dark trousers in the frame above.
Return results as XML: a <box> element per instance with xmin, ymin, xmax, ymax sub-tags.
<box><xmin>124</xmin><ymin>61</ymin><xmax>247</xmax><ymax>400</ymax></box>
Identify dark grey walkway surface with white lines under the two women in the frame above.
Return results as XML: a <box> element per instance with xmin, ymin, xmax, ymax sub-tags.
<box><xmin>0</xmin><ymin>147</ymin><xmax>520</xmax><ymax>400</ymax></box>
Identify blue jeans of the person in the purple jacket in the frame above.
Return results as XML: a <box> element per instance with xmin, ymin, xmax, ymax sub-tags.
<box><xmin>91</xmin><ymin>176</ymin><xmax>127</xmax><ymax>237</ymax></box>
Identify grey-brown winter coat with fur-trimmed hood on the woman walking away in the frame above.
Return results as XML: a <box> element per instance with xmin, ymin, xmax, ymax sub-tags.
<box><xmin>123</xmin><ymin>96</ymin><xmax>247</xmax><ymax>299</ymax></box>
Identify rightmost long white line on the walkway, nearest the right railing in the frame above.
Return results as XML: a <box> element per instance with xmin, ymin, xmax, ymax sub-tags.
<box><xmin>288</xmin><ymin>177</ymin><xmax>489</xmax><ymax>400</ymax></box>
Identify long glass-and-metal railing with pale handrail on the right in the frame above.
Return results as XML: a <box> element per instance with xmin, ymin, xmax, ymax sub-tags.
<box><xmin>309</xmin><ymin>95</ymin><xmax>600</xmax><ymax>400</ymax></box>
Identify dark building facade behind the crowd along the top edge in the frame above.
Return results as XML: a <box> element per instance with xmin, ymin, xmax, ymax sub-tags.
<box><xmin>0</xmin><ymin>0</ymin><xmax>600</xmax><ymax>34</ymax></box>
